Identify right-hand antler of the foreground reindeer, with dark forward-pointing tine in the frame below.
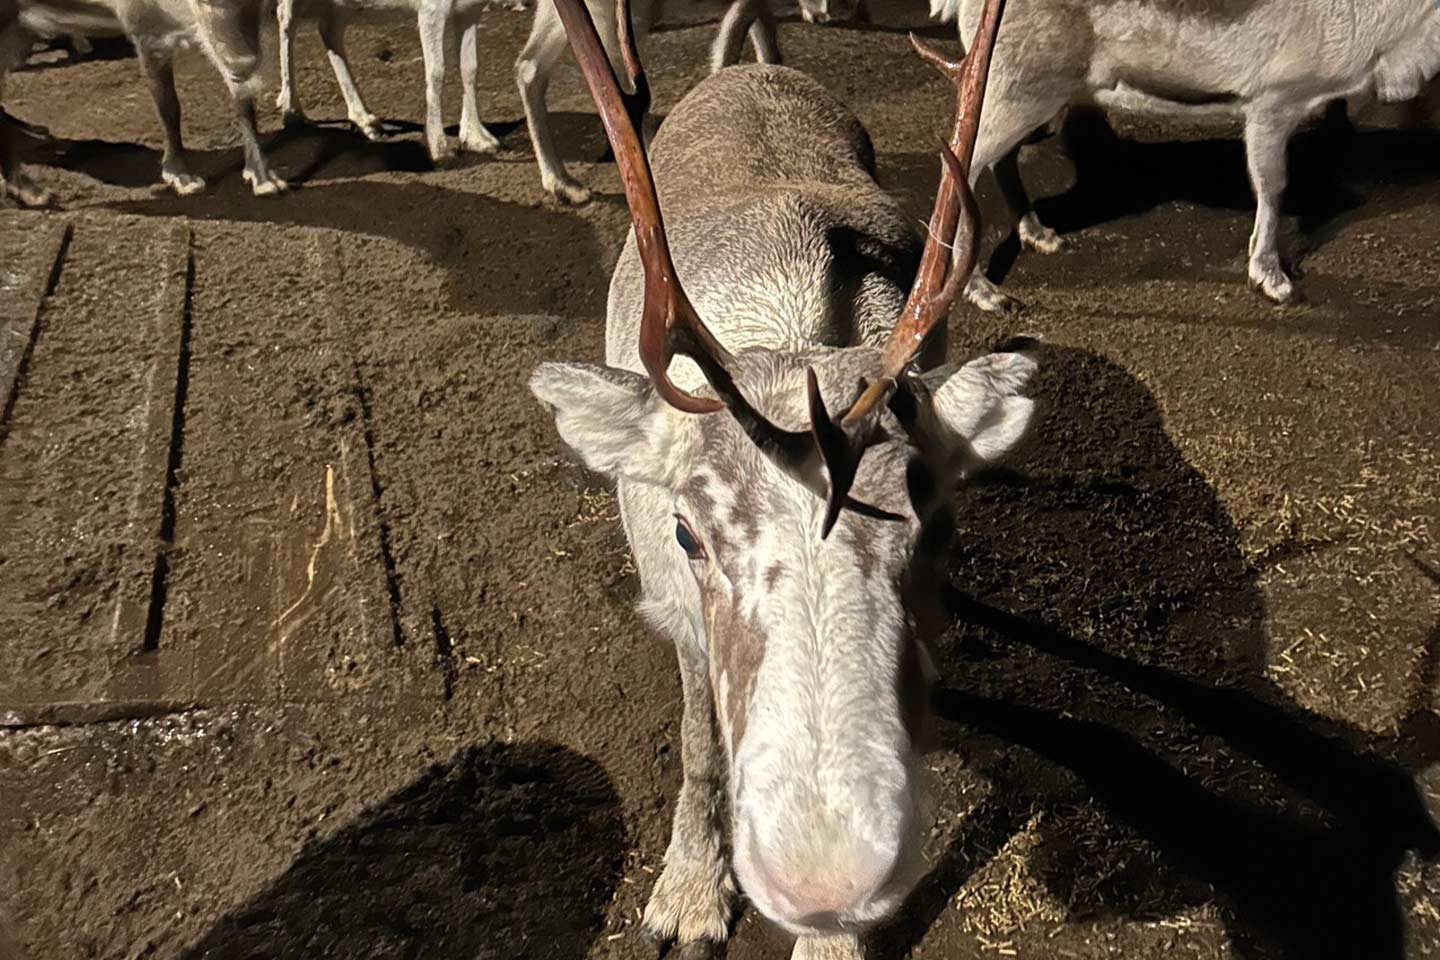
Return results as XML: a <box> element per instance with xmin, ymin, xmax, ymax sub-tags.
<box><xmin>811</xmin><ymin>0</ymin><xmax>1005</xmax><ymax>534</ymax></box>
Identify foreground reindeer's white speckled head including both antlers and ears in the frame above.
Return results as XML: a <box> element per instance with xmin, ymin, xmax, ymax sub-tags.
<box><xmin>530</xmin><ymin>0</ymin><xmax>1013</xmax><ymax>933</ymax></box>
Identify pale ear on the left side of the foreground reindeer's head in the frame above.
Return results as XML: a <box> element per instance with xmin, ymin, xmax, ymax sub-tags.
<box><xmin>530</xmin><ymin>363</ymin><xmax>691</xmax><ymax>486</ymax></box>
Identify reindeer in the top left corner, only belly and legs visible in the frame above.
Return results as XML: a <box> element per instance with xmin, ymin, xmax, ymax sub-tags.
<box><xmin>0</xmin><ymin>0</ymin><xmax>285</xmax><ymax>206</ymax></box>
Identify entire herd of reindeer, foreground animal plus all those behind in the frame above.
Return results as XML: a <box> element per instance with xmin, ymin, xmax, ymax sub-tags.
<box><xmin>0</xmin><ymin>0</ymin><xmax>1440</xmax><ymax>960</ymax></box>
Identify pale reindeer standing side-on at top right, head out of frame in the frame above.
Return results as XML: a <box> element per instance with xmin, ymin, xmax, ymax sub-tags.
<box><xmin>930</xmin><ymin>0</ymin><xmax>1440</xmax><ymax>311</ymax></box>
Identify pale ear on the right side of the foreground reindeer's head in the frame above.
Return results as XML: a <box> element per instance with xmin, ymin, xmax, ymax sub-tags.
<box><xmin>924</xmin><ymin>353</ymin><xmax>1037</xmax><ymax>462</ymax></box>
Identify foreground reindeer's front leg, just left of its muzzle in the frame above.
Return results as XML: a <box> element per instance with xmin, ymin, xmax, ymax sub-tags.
<box><xmin>645</xmin><ymin>638</ymin><xmax>736</xmax><ymax>960</ymax></box>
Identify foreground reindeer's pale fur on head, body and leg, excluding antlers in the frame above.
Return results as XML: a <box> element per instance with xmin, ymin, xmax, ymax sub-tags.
<box><xmin>531</xmin><ymin>68</ymin><xmax>1034</xmax><ymax>960</ymax></box>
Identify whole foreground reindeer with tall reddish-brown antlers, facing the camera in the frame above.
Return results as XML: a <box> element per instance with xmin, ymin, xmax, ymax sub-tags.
<box><xmin>530</xmin><ymin>0</ymin><xmax>1035</xmax><ymax>960</ymax></box>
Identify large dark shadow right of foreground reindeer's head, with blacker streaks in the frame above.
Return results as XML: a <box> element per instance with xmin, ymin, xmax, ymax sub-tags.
<box><xmin>873</xmin><ymin>347</ymin><xmax>1440</xmax><ymax>960</ymax></box>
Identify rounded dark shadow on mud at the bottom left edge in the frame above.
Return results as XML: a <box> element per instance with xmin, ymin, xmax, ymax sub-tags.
<box><xmin>183</xmin><ymin>744</ymin><xmax>628</xmax><ymax>960</ymax></box>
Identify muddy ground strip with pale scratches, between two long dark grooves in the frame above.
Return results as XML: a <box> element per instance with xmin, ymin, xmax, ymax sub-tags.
<box><xmin>161</xmin><ymin>229</ymin><xmax>433</xmax><ymax>708</ymax></box>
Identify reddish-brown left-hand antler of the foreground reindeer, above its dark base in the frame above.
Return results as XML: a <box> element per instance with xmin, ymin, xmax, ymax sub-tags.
<box><xmin>554</xmin><ymin>0</ymin><xmax>730</xmax><ymax>413</ymax></box>
